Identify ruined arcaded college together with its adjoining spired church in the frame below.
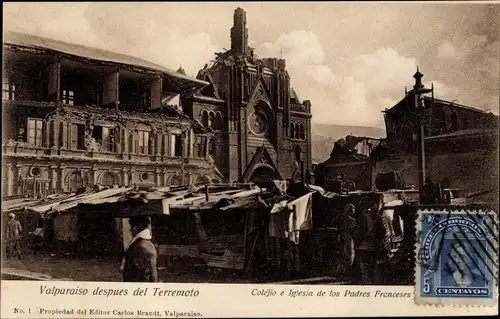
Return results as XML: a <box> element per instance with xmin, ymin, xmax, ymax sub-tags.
<box><xmin>2</xmin><ymin>8</ymin><xmax>311</xmax><ymax>197</ymax></box>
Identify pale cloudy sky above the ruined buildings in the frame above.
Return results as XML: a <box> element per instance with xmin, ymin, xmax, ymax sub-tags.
<box><xmin>3</xmin><ymin>2</ymin><xmax>500</xmax><ymax>128</ymax></box>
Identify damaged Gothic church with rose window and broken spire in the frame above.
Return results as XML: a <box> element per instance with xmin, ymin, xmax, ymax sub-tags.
<box><xmin>185</xmin><ymin>8</ymin><xmax>311</xmax><ymax>181</ymax></box>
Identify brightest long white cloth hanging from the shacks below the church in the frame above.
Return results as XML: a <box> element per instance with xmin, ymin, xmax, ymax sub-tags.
<box><xmin>287</xmin><ymin>192</ymin><xmax>314</xmax><ymax>244</ymax></box>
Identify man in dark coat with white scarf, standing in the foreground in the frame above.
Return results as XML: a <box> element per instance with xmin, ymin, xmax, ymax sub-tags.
<box><xmin>121</xmin><ymin>216</ymin><xmax>158</xmax><ymax>282</ymax></box>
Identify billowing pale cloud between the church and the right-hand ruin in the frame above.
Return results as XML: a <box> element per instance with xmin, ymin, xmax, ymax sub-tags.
<box><xmin>258</xmin><ymin>30</ymin><xmax>416</xmax><ymax>127</ymax></box>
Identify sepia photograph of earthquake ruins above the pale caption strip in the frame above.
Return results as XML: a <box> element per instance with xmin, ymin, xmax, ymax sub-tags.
<box><xmin>1</xmin><ymin>2</ymin><xmax>500</xmax><ymax>318</ymax></box>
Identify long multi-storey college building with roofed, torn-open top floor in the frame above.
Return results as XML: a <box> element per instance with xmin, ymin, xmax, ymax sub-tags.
<box><xmin>2</xmin><ymin>33</ymin><xmax>224</xmax><ymax>197</ymax></box>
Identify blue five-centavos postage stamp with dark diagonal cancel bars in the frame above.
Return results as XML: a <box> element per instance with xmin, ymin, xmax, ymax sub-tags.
<box><xmin>415</xmin><ymin>208</ymin><xmax>498</xmax><ymax>305</ymax></box>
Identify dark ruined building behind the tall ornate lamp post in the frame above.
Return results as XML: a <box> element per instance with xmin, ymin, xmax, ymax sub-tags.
<box><xmin>370</xmin><ymin>79</ymin><xmax>498</xmax><ymax>199</ymax></box>
